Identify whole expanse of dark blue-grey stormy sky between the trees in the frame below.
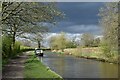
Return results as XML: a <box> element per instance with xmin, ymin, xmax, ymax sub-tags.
<box><xmin>52</xmin><ymin>2</ymin><xmax>103</xmax><ymax>34</ymax></box>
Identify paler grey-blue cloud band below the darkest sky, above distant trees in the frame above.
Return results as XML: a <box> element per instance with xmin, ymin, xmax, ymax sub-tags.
<box><xmin>53</xmin><ymin>23</ymin><xmax>102</xmax><ymax>34</ymax></box>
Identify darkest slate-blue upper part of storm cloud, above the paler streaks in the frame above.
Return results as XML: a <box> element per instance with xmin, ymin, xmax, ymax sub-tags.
<box><xmin>58</xmin><ymin>2</ymin><xmax>102</xmax><ymax>24</ymax></box>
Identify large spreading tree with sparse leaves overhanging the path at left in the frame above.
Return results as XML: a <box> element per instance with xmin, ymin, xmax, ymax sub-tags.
<box><xmin>2</xmin><ymin>2</ymin><xmax>62</xmax><ymax>44</ymax></box>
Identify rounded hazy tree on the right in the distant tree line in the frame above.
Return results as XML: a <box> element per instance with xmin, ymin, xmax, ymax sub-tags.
<box><xmin>81</xmin><ymin>33</ymin><xmax>94</xmax><ymax>47</ymax></box>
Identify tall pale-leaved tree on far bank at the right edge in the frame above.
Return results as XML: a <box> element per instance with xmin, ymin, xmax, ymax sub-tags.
<box><xmin>99</xmin><ymin>2</ymin><xmax>120</xmax><ymax>54</ymax></box>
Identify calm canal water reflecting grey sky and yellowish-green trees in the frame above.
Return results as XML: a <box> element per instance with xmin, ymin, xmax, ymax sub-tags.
<box><xmin>42</xmin><ymin>52</ymin><xmax>118</xmax><ymax>78</ymax></box>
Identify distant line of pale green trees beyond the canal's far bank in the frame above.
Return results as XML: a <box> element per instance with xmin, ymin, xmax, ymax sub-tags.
<box><xmin>50</xmin><ymin>32</ymin><xmax>100</xmax><ymax>50</ymax></box>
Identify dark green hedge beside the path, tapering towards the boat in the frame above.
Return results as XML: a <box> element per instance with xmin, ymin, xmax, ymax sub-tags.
<box><xmin>2</xmin><ymin>36</ymin><xmax>33</xmax><ymax>65</ymax></box>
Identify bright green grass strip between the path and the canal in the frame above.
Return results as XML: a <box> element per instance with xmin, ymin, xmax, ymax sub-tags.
<box><xmin>24</xmin><ymin>52</ymin><xmax>63</xmax><ymax>80</ymax></box>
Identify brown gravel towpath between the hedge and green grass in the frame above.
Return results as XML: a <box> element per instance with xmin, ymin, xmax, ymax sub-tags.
<box><xmin>2</xmin><ymin>53</ymin><xmax>27</xmax><ymax>80</ymax></box>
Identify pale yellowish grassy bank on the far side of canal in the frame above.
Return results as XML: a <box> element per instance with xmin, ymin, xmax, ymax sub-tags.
<box><xmin>53</xmin><ymin>47</ymin><xmax>120</xmax><ymax>64</ymax></box>
